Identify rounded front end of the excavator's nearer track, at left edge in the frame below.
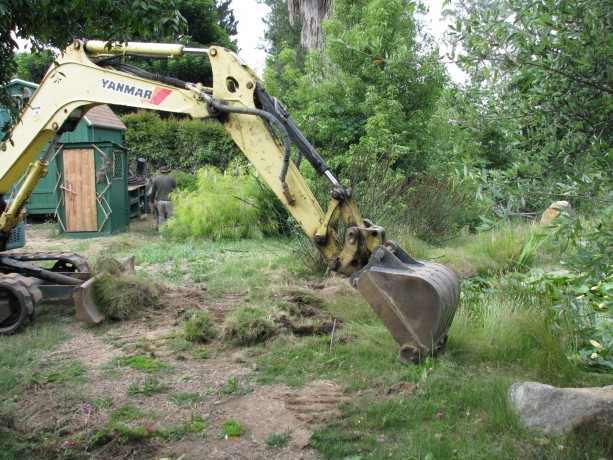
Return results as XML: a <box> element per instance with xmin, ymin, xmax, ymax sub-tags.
<box><xmin>0</xmin><ymin>273</ymin><xmax>43</xmax><ymax>335</ymax></box>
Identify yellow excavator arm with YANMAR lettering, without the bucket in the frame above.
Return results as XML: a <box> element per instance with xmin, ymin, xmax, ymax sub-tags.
<box><xmin>0</xmin><ymin>41</ymin><xmax>372</xmax><ymax>274</ymax></box>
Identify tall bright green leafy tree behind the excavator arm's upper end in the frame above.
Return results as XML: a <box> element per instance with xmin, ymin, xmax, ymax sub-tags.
<box><xmin>264</xmin><ymin>0</ymin><xmax>445</xmax><ymax>176</ymax></box>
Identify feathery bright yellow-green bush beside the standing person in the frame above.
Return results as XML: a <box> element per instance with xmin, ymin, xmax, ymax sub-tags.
<box><xmin>163</xmin><ymin>163</ymin><xmax>278</xmax><ymax>240</ymax></box>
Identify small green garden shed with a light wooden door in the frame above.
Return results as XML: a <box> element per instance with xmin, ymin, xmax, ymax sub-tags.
<box><xmin>2</xmin><ymin>79</ymin><xmax>130</xmax><ymax>237</ymax></box>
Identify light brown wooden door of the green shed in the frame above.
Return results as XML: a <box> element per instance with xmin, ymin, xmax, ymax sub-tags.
<box><xmin>63</xmin><ymin>149</ymin><xmax>98</xmax><ymax>232</ymax></box>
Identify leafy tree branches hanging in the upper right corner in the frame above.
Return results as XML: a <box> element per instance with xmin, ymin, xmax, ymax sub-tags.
<box><xmin>450</xmin><ymin>0</ymin><xmax>613</xmax><ymax>205</ymax></box>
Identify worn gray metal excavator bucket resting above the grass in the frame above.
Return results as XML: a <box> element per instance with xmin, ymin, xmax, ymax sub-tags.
<box><xmin>351</xmin><ymin>242</ymin><xmax>460</xmax><ymax>364</ymax></box>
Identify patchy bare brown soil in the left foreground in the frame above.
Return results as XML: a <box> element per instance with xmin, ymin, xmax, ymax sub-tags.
<box><xmin>9</xmin><ymin>225</ymin><xmax>347</xmax><ymax>460</ymax></box>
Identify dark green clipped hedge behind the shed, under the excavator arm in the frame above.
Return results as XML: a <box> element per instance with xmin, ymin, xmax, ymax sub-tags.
<box><xmin>121</xmin><ymin>111</ymin><xmax>242</xmax><ymax>173</ymax></box>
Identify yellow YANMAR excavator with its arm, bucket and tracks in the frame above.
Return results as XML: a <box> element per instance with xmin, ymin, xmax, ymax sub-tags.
<box><xmin>0</xmin><ymin>40</ymin><xmax>460</xmax><ymax>363</ymax></box>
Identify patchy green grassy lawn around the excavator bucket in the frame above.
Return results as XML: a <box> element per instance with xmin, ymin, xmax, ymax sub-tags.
<box><xmin>0</xmin><ymin>218</ymin><xmax>613</xmax><ymax>459</ymax></box>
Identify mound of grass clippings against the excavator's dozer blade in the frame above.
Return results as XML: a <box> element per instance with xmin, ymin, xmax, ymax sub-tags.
<box><xmin>93</xmin><ymin>273</ymin><xmax>160</xmax><ymax>320</ymax></box>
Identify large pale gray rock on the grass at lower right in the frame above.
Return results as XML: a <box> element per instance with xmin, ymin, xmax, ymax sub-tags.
<box><xmin>508</xmin><ymin>382</ymin><xmax>613</xmax><ymax>437</ymax></box>
